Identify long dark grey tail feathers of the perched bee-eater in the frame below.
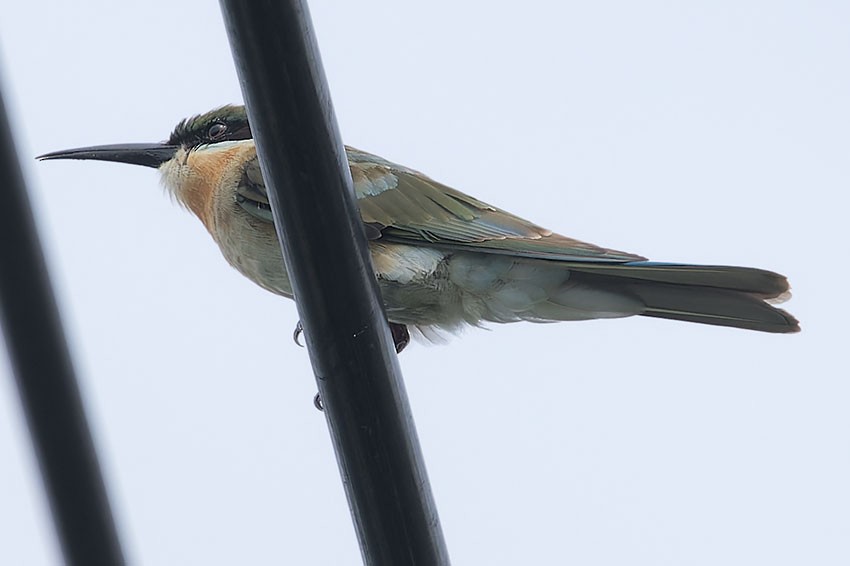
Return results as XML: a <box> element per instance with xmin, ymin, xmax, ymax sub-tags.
<box><xmin>569</xmin><ymin>262</ymin><xmax>800</xmax><ymax>333</ymax></box>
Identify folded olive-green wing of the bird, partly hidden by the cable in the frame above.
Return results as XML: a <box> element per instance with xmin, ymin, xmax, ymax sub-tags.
<box><xmin>238</xmin><ymin>147</ymin><xmax>645</xmax><ymax>262</ymax></box>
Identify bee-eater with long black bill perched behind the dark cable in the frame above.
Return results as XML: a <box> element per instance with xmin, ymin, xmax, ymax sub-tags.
<box><xmin>37</xmin><ymin>105</ymin><xmax>800</xmax><ymax>352</ymax></box>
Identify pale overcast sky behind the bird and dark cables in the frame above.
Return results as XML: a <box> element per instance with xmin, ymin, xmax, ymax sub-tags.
<box><xmin>0</xmin><ymin>0</ymin><xmax>850</xmax><ymax>566</ymax></box>
